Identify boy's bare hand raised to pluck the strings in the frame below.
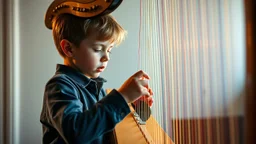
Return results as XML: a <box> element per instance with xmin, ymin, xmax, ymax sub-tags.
<box><xmin>118</xmin><ymin>70</ymin><xmax>152</xmax><ymax>103</ymax></box>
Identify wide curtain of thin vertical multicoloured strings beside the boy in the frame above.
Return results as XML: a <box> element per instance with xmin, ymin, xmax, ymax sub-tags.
<box><xmin>138</xmin><ymin>0</ymin><xmax>242</xmax><ymax>144</ymax></box>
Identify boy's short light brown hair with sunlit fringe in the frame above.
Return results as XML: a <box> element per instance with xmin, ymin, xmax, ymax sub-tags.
<box><xmin>52</xmin><ymin>14</ymin><xmax>126</xmax><ymax>57</ymax></box>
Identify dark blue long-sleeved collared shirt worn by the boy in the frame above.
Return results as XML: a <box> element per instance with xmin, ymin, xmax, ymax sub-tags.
<box><xmin>40</xmin><ymin>64</ymin><xmax>130</xmax><ymax>144</ymax></box>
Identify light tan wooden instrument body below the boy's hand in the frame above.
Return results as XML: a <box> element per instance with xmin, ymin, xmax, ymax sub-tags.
<box><xmin>115</xmin><ymin>104</ymin><xmax>174</xmax><ymax>144</ymax></box>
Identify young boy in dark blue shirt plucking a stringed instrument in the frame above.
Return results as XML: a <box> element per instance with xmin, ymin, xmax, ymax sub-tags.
<box><xmin>40</xmin><ymin>3</ymin><xmax>152</xmax><ymax>144</ymax></box>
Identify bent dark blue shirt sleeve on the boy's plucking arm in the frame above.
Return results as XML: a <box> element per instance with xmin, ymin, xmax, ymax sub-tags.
<box><xmin>45</xmin><ymin>76</ymin><xmax>130</xmax><ymax>143</ymax></box>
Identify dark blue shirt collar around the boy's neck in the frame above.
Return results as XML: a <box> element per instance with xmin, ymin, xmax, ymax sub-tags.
<box><xmin>56</xmin><ymin>64</ymin><xmax>107</xmax><ymax>87</ymax></box>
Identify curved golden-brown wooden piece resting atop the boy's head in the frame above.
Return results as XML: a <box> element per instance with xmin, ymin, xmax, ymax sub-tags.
<box><xmin>44</xmin><ymin>0</ymin><xmax>123</xmax><ymax>29</ymax></box>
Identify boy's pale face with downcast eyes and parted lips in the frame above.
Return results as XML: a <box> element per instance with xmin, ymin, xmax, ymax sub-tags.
<box><xmin>72</xmin><ymin>33</ymin><xmax>114</xmax><ymax>78</ymax></box>
